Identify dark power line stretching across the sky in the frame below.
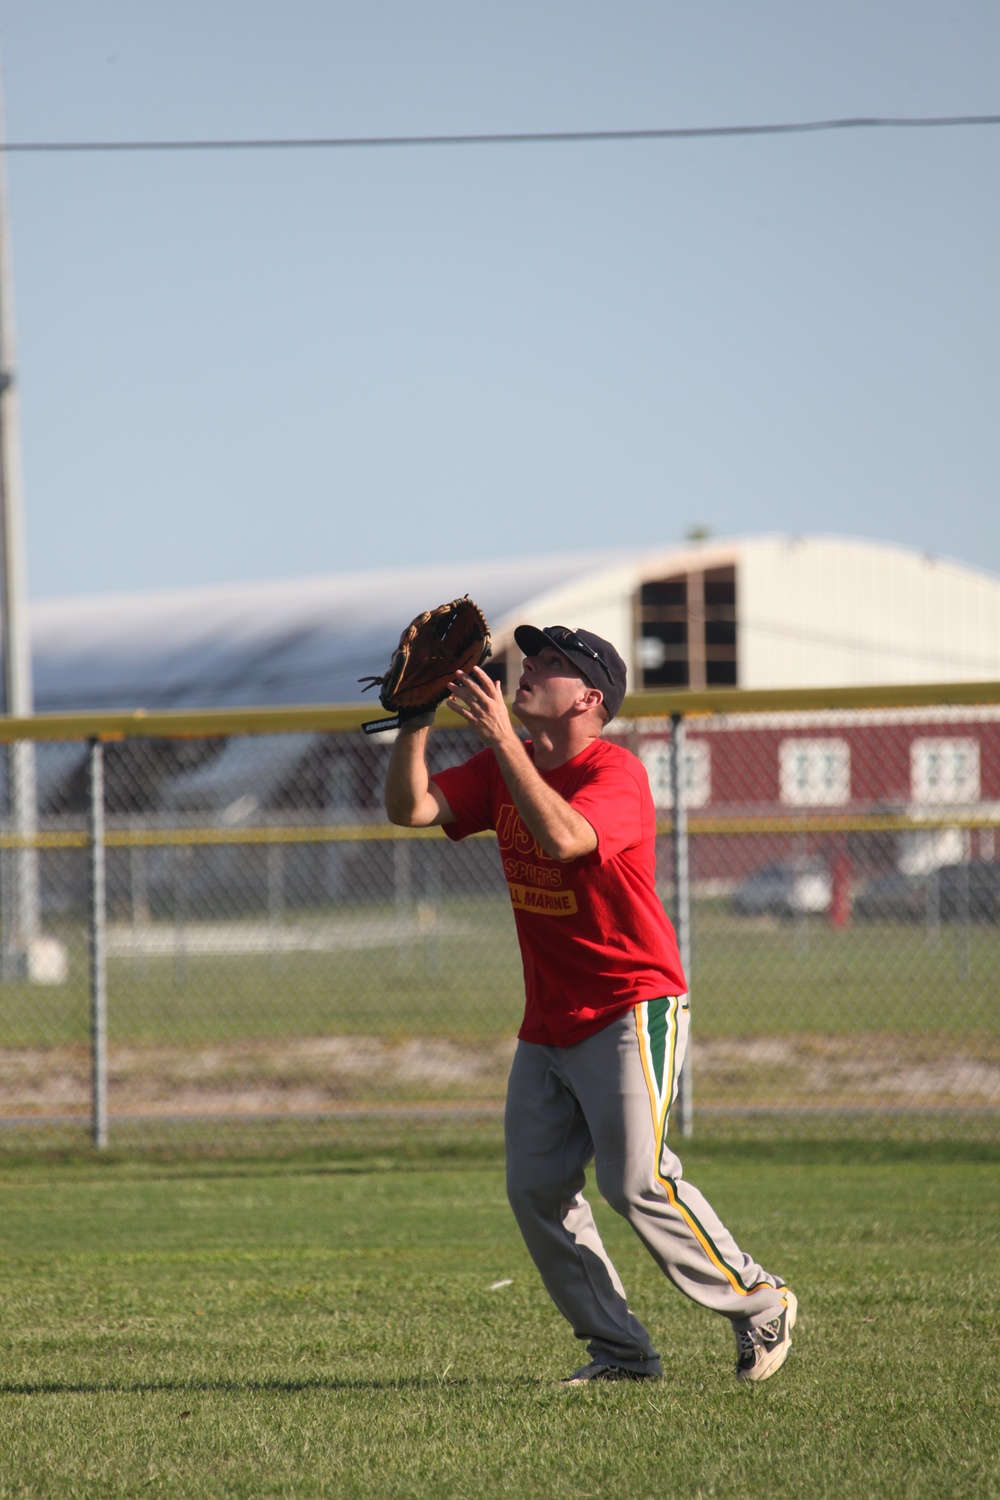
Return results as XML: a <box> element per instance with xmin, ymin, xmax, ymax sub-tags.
<box><xmin>0</xmin><ymin>114</ymin><xmax>1000</xmax><ymax>155</ymax></box>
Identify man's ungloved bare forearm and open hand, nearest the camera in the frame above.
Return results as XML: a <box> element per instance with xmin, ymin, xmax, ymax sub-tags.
<box><xmin>450</xmin><ymin>668</ymin><xmax>597</xmax><ymax>863</ymax></box>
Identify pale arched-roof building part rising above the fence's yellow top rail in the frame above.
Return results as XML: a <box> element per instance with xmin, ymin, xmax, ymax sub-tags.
<box><xmin>30</xmin><ymin>536</ymin><xmax>1000</xmax><ymax>713</ymax></box>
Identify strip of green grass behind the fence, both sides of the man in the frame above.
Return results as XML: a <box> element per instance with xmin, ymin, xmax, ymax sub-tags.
<box><xmin>0</xmin><ymin>899</ymin><xmax>1000</xmax><ymax>1046</ymax></box>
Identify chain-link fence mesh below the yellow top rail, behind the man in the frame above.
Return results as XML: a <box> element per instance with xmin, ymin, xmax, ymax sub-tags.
<box><xmin>0</xmin><ymin>695</ymin><xmax>1000</xmax><ymax>1152</ymax></box>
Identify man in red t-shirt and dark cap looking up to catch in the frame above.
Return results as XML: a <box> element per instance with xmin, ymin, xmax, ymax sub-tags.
<box><xmin>385</xmin><ymin>626</ymin><xmax>796</xmax><ymax>1385</ymax></box>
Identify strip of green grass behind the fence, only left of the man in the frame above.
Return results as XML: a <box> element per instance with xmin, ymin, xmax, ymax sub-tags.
<box><xmin>0</xmin><ymin>900</ymin><xmax>523</xmax><ymax>1046</ymax></box>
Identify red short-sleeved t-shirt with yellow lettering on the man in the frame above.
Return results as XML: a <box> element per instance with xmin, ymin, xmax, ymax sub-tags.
<box><xmin>433</xmin><ymin>740</ymin><xmax>687</xmax><ymax>1047</ymax></box>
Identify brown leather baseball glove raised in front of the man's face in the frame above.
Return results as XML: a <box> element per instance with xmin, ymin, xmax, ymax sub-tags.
<box><xmin>358</xmin><ymin>594</ymin><xmax>492</xmax><ymax>735</ymax></box>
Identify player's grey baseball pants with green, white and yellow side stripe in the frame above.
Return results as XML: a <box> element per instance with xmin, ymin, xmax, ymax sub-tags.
<box><xmin>505</xmin><ymin>998</ymin><xmax>784</xmax><ymax>1371</ymax></box>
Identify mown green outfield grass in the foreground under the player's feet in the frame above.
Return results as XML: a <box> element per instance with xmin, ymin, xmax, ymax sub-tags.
<box><xmin>0</xmin><ymin>1146</ymin><xmax>1000</xmax><ymax>1500</ymax></box>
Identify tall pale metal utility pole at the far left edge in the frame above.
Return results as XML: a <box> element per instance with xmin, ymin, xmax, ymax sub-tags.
<box><xmin>0</xmin><ymin>58</ymin><xmax>39</xmax><ymax>978</ymax></box>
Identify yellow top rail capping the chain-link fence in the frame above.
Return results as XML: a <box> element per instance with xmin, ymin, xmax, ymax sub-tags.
<box><xmin>0</xmin><ymin>683</ymin><xmax>1000</xmax><ymax>744</ymax></box>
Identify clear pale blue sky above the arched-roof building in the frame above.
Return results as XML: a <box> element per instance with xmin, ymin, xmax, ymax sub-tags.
<box><xmin>0</xmin><ymin>0</ymin><xmax>1000</xmax><ymax>597</ymax></box>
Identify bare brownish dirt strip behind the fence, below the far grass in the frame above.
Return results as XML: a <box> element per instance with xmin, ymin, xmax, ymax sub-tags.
<box><xmin>0</xmin><ymin>1034</ymin><xmax>1000</xmax><ymax>1119</ymax></box>
